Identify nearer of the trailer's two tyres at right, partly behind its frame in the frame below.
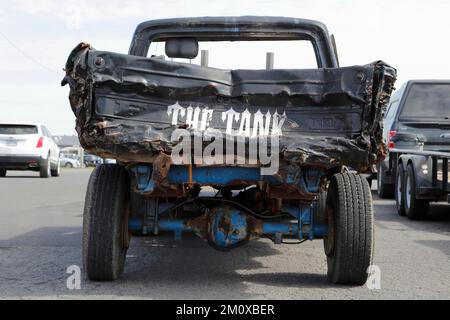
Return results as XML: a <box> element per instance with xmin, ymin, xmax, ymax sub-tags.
<box><xmin>403</xmin><ymin>164</ymin><xmax>430</xmax><ymax>220</ymax></box>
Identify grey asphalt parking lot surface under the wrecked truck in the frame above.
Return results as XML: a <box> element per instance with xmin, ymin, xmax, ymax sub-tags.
<box><xmin>0</xmin><ymin>169</ymin><xmax>450</xmax><ymax>299</ymax></box>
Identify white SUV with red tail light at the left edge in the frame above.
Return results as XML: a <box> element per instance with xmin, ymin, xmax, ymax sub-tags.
<box><xmin>0</xmin><ymin>123</ymin><xmax>60</xmax><ymax>178</ymax></box>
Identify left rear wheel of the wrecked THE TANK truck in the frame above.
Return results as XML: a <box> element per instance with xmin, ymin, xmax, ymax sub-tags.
<box><xmin>83</xmin><ymin>164</ymin><xmax>130</xmax><ymax>281</ymax></box>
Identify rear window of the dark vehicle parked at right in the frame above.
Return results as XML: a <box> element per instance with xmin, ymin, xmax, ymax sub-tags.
<box><xmin>401</xmin><ymin>83</ymin><xmax>450</xmax><ymax>119</ymax></box>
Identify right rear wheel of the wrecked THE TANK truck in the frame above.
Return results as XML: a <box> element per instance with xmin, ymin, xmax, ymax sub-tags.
<box><xmin>324</xmin><ymin>173</ymin><xmax>374</xmax><ymax>285</ymax></box>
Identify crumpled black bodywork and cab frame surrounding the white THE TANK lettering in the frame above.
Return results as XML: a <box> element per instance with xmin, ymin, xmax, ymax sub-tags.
<box><xmin>63</xmin><ymin>17</ymin><xmax>396</xmax><ymax>180</ymax></box>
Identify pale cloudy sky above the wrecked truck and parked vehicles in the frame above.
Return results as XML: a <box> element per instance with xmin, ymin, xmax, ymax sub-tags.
<box><xmin>0</xmin><ymin>0</ymin><xmax>450</xmax><ymax>135</ymax></box>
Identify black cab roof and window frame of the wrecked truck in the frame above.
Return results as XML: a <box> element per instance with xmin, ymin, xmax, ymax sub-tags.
<box><xmin>129</xmin><ymin>16</ymin><xmax>338</xmax><ymax>68</ymax></box>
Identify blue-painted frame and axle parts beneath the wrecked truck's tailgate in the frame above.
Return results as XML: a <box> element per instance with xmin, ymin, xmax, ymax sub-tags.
<box><xmin>129</xmin><ymin>165</ymin><xmax>327</xmax><ymax>245</ymax></box>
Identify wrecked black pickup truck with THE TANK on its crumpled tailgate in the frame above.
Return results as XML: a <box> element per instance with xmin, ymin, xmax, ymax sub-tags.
<box><xmin>62</xmin><ymin>17</ymin><xmax>396</xmax><ymax>284</ymax></box>
